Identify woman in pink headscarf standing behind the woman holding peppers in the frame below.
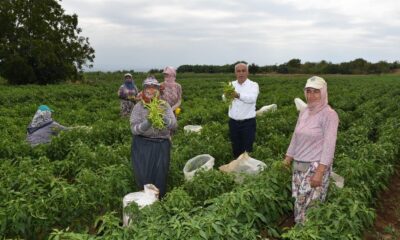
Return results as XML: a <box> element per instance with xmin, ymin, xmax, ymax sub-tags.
<box><xmin>161</xmin><ymin>66</ymin><xmax>182</xmax><ymax>115</ymax></box>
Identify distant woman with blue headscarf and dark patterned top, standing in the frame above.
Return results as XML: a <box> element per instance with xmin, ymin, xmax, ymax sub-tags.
<box><xmin>118</xmin><ymin>73</ymin><xmax>139</xmax><ymax>117</ymax></box>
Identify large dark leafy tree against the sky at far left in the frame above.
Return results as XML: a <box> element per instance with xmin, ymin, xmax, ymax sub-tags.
<box><xmin>0</xmin><ymin>0</ymin><xmax>95</xmax><ymax>84</ymax></box>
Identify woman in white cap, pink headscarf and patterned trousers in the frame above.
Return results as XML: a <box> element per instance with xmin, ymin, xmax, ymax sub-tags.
<box><xmin>283</xmin><ymin>76</ymin><xmax>339</xmax><ymax>223</ymax></box>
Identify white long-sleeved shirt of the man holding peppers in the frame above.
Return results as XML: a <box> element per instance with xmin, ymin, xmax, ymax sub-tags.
<box><xmin>228</xmin><ymin>79</ymin><xmax>260</xmax><ymax>120</ymax></box>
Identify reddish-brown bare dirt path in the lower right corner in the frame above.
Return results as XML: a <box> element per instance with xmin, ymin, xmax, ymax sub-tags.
<box><xmin>363</xmin><ymin>166</ymin><xmax>400</xmax><ymax>240</ymax></box>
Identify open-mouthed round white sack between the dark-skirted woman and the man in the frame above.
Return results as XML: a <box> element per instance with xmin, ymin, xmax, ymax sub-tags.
<box><xmin>183</xmin><ymin>154</ymin><xmax>215</xmax><ymax>180</ymax></box>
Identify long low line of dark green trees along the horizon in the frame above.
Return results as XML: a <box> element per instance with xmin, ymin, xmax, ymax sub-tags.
<box><xmin>177</xmin><ymin>58</ymin><xmax>400</xmax><ymax>74</ymax></box>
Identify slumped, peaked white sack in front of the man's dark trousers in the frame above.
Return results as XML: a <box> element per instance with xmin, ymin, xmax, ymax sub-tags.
<box><xmin>219</xmin><ymin>152</ymin><xmax>267</xmax><ymax>180</ymax></box>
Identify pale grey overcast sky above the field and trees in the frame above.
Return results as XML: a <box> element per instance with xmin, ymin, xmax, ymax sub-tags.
<box><xmin>61</xmin><ymin>0</ymin><xmax>400</xmax><ymax>71</ymax></box>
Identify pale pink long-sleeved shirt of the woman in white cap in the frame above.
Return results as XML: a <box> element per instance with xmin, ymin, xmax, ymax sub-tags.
<box><xmin>286</xmin><ymin>106</ymin><xmax>339</xmax><ymax>166</ymax></box>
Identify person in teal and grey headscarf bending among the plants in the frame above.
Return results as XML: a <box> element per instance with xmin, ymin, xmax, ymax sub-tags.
<box><xmin>26</xmin><ymin>105</ymin><xmax>69</xmax><ymax>146</ymax></box>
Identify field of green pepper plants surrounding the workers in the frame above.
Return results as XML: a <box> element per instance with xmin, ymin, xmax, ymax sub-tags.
<box><xmin>0</xmin><ymin>73</ymin><xmax>400</xmax><ymax>239</ymax></box>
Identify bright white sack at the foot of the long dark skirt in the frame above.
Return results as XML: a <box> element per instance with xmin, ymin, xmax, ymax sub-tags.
<box><xmin>122</xmin><ymin>184</ymin><xmax>160</xmax><ymax>227</ymax></box>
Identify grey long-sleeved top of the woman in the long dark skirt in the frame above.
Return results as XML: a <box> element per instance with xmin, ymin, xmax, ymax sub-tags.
<box><xmin>130</xmin><ymin>102</ymin><xmax>177</xmax><ymax>139</ymax></box>
